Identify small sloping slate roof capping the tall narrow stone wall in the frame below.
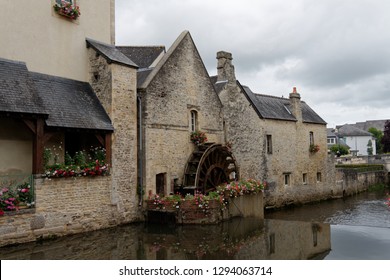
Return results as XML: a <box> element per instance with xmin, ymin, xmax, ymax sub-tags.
<box><xmin>87</xmin><ymin>39</ymin><xmax>138</xmax><ymax>68</ymax></box>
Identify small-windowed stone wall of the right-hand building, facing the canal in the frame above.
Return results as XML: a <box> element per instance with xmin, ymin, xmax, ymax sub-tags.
<box><xmin>265</xmin><ymin>120</ymin><xmax>334</xmax><ymax>207</ymax></box>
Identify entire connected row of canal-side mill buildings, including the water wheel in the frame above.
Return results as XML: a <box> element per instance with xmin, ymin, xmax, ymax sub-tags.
<box><xmin>0</xmin><ymin>0</ymin><xmax>331</xmax><ymax>246</ymax></box>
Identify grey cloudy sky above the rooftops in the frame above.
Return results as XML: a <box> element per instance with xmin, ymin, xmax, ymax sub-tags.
<box><xmin>116</xmin><ymin>0</ymin><xmax>390</xmax><ymax>127</ymax></box>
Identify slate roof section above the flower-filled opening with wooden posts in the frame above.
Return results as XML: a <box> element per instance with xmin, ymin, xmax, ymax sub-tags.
<box><xmin>31</xmin><ymin>73</ymin><xmax>114</xmax><ymax>131</ymax></box>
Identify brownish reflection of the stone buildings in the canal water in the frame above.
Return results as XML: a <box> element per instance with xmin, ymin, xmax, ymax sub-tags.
<box><xmin>0</xmin><ymin>218</ymin><xmax>330</xmax><ymax>260</ymax></box>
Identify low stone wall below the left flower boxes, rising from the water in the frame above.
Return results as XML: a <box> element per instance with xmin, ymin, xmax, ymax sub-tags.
<box><xmin>0</xmin><ymin>176</ymin><xmax>140</xmax><ymax>246</ymax></box>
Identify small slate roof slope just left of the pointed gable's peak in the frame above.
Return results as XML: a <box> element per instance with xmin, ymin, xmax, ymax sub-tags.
<box><xmin>116</xmin><ymin>46</ymin><xmax>165</xmax><ymax>68</ymax></box>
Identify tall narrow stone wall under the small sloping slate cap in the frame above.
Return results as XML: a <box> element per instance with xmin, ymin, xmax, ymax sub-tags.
<box><xmin>88</xmin><ymin>48</ymin><xmax>141</xmax><ymax>222</ymax></box>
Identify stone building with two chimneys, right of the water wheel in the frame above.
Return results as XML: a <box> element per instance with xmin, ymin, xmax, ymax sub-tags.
<box><xmin>213</xmin><ymin>52</ymin><xmax>333</xmax><ymax>207</ymax></box>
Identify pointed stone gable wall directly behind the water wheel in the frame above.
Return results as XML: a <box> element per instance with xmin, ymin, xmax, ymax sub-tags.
<box><xmin>142</xmin><ymin>33</ymin><xmax>224</xmax><ymax>194</ymax></box>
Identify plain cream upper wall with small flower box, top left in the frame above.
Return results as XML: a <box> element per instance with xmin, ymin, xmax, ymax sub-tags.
<box><xmin>0</xmin><ymin>0</ymin><xmax>115</xmax><ymax>81</ymax></box>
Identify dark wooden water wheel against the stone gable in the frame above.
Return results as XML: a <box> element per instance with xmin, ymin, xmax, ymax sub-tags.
<box><xmin>184</xmin><ymin>143</ymin><xmax>239</xmax><ymax>194</ymax></box>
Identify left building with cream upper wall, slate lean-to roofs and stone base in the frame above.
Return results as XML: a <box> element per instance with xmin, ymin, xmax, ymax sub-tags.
<box><xmin>0</xmin><ymin>0</ymin><xmax>143</xmax><ymax>246</ymax></box>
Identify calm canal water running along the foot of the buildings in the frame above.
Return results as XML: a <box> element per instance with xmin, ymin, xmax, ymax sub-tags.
<box><xmin>0</xmin><ymin>192</ymin><xmax>390</xmax><ymax>260</ymax></box>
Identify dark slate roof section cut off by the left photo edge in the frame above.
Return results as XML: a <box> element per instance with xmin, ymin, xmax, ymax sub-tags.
<box><xmin>0</xmin><ymin>58</ymin><xmax>48</xmax><ymax>115</ymax></box>
